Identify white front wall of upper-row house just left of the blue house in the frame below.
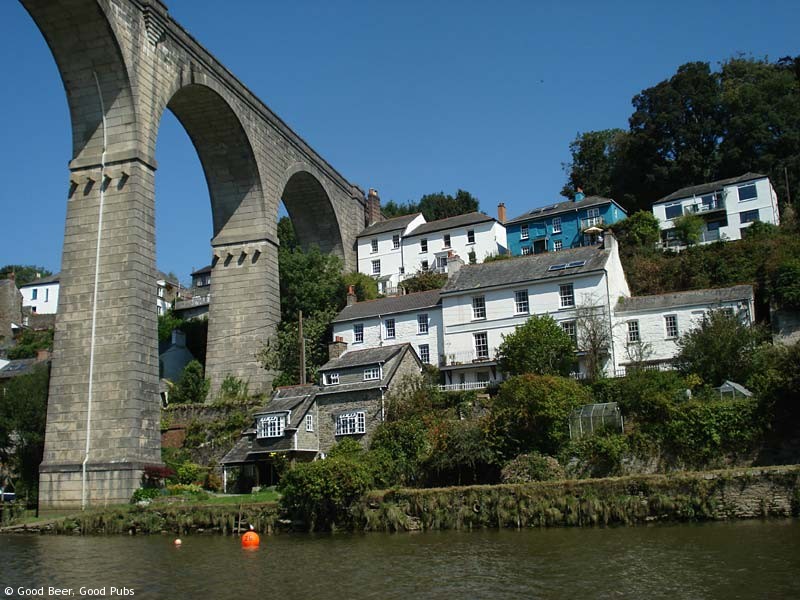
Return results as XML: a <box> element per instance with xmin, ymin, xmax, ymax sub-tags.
<box><xmin>403</xmin><ymin>221</ymin><xmax>507</xmax><ymax>276</ymax></box>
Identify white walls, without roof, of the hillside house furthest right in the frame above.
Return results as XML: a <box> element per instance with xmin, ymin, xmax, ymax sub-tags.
<box><xmin>653</xmin><ymin>177</ymin><xmax>780</xmax><ymax>243</ymax></box>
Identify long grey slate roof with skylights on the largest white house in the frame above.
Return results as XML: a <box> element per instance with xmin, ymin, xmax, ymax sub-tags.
<box><xmin>441</xmin><ymin>246</ymin><xmax>611</xmax><ymax>296</ymax></box>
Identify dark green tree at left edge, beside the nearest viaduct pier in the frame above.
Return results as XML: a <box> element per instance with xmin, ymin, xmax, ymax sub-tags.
<box><xmin>0</xmin><ymin>364</ymin><xmax>50</xmax><ymax>504</ymax></box>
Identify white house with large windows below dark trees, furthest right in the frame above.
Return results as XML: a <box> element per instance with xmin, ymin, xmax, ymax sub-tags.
<box><xmin>653</xmin><ymin>173</ymin><xmax>780</xmax><ymax>248</ymax></box>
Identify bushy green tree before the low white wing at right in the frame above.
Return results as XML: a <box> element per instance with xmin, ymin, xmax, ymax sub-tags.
<box><xmin>675</xmin><ymin>310</ymin><xmax>765</xmax><ymax>385</ymax></box>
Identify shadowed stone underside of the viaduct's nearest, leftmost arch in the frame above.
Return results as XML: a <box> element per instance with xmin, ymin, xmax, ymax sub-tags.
<box><xmin>22</xmin><ymin>0</ymin><xmax>138</xmax><ymax>169</ymax></box>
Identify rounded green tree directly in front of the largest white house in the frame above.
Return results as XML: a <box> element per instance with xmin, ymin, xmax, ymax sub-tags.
<box><xmin>497</xmin><ymin>316</ymin><xmax>576</xmax><ymax>375</ymax></box>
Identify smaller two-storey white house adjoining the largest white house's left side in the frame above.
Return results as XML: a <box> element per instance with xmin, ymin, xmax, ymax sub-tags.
<box><xmin>333</xmin><ymin>290</ymin><xmax>442</xmax><ymax>365</ymax></box>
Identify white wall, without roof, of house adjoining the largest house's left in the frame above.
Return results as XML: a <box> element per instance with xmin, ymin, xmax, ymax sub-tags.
<box><xmin>333</xmin><ymin>306</ymin><xmax>442</xmax><ymax>365</ymax></box>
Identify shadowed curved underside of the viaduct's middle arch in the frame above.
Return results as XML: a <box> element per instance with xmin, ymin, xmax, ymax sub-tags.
<box><xmin>159</xmin><ymin>83</ymin><xmax>268</xmax><ymax>245</ymax></box>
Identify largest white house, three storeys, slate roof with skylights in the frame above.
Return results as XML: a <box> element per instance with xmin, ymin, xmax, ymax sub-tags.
<box><xmin>439</xmin><ymin>235</ymin><xmax>630</xmax><ymax>389</ymax></box>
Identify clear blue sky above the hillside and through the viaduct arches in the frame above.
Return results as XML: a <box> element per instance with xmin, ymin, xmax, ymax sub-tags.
<box><xmin>0</xmin><ymin>0</ymin><xmax>800</xmax><ymax>280</ymax></box>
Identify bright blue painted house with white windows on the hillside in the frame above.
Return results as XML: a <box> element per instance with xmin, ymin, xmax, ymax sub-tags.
<box><xmin>505</xmin><ymin>190</ymin><xmax>628</xmax><ymax>256</ymax></box>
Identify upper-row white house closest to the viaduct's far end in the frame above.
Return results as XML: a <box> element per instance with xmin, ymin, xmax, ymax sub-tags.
<box><xmin>356</xmin><ymin>213</ymin><xmax>425</xmax><ymax>294</ymax></box>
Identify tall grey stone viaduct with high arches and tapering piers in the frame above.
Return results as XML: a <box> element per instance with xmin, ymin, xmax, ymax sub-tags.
<box><xmin>20</xmin><ymin>0</ymin><xmax>366</xmax><ymax>511</ymax></box>
